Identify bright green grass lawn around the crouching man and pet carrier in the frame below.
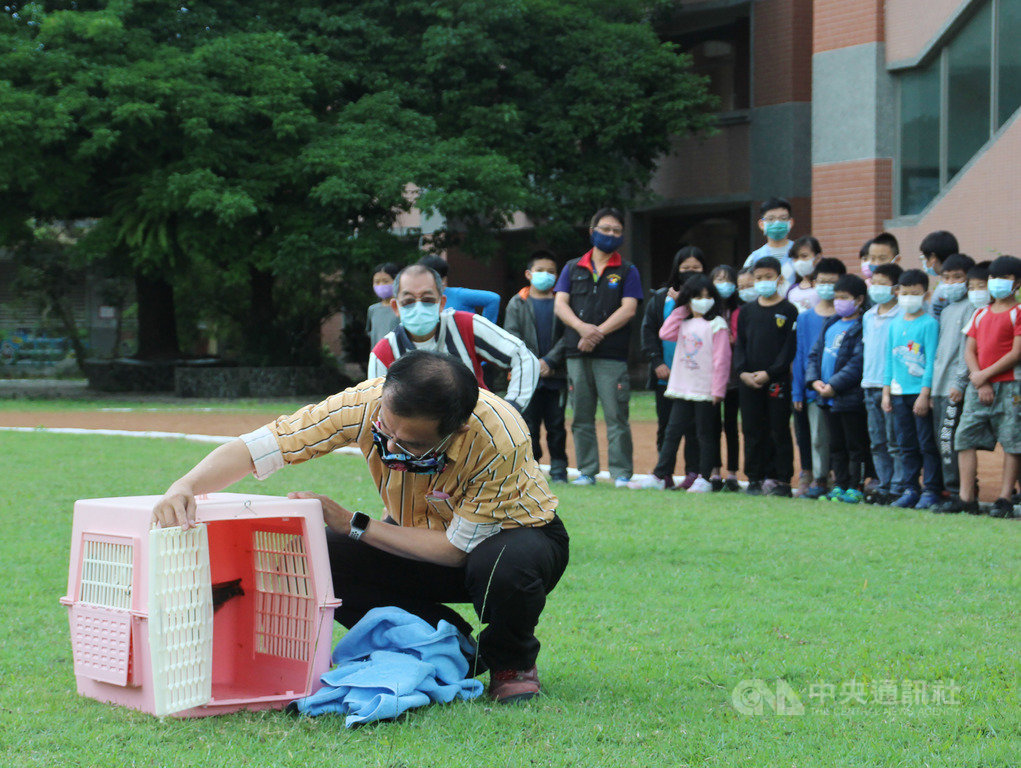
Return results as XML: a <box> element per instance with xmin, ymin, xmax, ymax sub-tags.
<box><xmin>0</xmin><ymin>433</ymin><xmax>1021</xmax><ymax>768</ymax></box>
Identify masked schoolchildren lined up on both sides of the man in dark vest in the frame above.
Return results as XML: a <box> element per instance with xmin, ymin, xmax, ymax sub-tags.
<box><xmin>378</xmin><ymin>198</ymin><xmax>1021</xmax><ymax>517</ymax></box>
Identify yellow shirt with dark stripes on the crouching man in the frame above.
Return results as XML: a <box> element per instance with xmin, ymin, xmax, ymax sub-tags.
<box><xmin>242</xmin><ymin>379</ymin><xmax>557</xmax><ymax>551</ymax></box>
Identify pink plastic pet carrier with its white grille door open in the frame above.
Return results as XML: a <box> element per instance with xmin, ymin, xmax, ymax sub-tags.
<box><xmin>60</xmin><ymin>493</ymin><xmax>340</xmax><ymax>717</ymax></box>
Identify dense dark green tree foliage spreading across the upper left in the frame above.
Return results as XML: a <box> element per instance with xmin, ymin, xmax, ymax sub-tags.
<box><xmin>0</xmin><ymin>0</ymin><xmax>710</xmax><ymax>362</ymax></box>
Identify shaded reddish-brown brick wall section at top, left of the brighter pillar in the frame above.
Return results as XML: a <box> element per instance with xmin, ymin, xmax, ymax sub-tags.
<box><xmin>751</xmin><ymin>0</ymin><xmax>812</xmax><ymax>106</ymax></box>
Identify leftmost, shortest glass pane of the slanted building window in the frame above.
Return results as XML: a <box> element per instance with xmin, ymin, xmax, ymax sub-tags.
<box><xmin>901</xmin><ymin>59</ymin><xmax>939</xmax><ymax>214</ymax></box>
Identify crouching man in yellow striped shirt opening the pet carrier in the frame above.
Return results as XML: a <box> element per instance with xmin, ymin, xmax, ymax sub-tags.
<box><xmin>153</xmin><ymin>351</ymin><xmax>569</xmax><ymax>703</ymax></box>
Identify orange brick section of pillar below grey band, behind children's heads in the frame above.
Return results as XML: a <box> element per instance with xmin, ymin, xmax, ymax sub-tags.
<box><xmin>812</xmin><ymin>158</ymin><xmax>893</xmax><ymax>271</ymax></box>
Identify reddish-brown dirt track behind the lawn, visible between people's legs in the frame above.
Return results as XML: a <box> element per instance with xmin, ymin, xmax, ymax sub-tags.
<box><xmin>0</xmin><ymin>411</ymin><xmax>1004</xmax><ymax>501</ymax></box>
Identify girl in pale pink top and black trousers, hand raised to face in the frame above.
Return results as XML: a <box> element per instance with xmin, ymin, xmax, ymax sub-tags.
<box><xmin>629</xmin><ymin>275</ymin><xmax>731</xmax><ymax>493</ymax></box>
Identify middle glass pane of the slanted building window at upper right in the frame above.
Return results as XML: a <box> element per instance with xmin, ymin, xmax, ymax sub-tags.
<box><xmin>946</xmin><ymin>3</ymin><xmax>992</xmax><ymax>179</ymax></box>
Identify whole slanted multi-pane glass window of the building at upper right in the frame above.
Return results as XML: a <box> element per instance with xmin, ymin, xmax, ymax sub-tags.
<box><xmin>898</xmin><ymin>0</ymin><xmax>1021</xmax><ymax>215</ymax></box>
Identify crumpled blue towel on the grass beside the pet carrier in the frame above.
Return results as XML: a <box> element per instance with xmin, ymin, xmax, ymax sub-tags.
<box><xmin>292</xmin><ymin>608</ymin><xmax>483</xmax><ymax>728</ymax></box>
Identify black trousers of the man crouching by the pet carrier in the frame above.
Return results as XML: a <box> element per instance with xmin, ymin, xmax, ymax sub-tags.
<box><xmin>327</xmin><ymin>518</ymin><xmax>569</xmax><ymax>670</ymax></box>
